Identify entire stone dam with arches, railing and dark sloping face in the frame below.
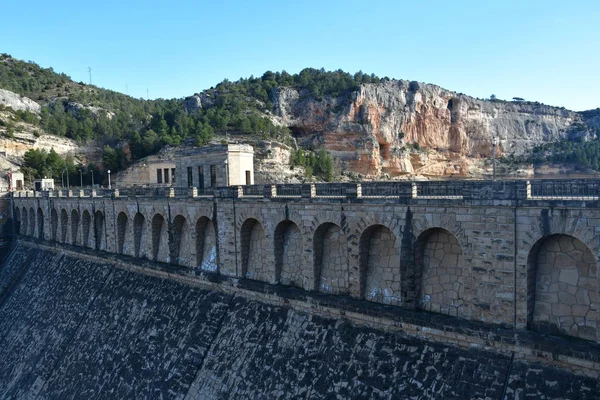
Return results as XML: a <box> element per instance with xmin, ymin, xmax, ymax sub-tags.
<box><xmin>0</xmin><ymin>181</ymin><xmax>600</xmax><ymax>399</ymax></box>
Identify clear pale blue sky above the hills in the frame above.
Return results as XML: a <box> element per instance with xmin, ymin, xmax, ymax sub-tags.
<box><xmin>0</xmin><ymin>0</ymin><xmax>600</xmax><ymax>110</ymax></box>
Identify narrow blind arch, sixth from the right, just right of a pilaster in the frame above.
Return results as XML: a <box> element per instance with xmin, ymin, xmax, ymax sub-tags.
<box><xmin>240</xmin><ymin>218</ymin><xmax>267</xmax><ymax>281</ymax></box>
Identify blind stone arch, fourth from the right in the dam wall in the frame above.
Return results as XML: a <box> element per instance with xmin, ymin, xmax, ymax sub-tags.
<box><xmin>313</xmin><ymin>222</ymin><xmax>348</xmax><ymax>294</ymax></box>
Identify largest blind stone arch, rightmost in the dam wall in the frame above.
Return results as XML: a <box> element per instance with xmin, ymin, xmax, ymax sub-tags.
<box><xmin>527</xmin><ymin>234</ymin><xmax>599</xmax><ymax>341</ymax></box>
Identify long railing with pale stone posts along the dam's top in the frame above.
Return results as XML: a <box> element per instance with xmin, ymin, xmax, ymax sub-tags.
<box><xmin>13</xmin><ymin>179</ymin><xmax>600</xmax><ymax>201</ymax></box>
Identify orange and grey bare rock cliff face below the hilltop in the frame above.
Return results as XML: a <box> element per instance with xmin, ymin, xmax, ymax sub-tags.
<box><xmin>272</xmin><ymin>80</ymin><xmax>589</xmax><ymax>177</ymax></box>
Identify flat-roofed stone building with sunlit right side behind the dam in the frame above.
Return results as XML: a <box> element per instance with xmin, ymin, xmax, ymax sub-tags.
<box><xmin>175</xmin><ymin>144</ymin><xmax>254</xmax><ymax>189</ymax></box>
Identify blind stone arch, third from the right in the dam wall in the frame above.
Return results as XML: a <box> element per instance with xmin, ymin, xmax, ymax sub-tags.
<box><xmin>359</xmin><ymin>224</ymin><xmax>402</xmax><ymax>305</ymax></box>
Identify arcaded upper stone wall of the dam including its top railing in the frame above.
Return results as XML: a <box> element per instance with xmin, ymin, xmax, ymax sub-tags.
<box><xmin>11</xmin><ymin>180</ymin><xmax>600</xmax><ymax>341</ymax></box>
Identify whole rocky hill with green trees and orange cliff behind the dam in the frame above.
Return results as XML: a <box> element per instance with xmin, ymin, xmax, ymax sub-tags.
<box><xmin>0</xmin><ymin>55</ymin><xmax>600</xmax><ymax>180</ymax></box>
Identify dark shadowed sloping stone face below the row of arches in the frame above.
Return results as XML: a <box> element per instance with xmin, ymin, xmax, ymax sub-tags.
<box><xmin>0</xmin><ymin>242</ymin><xmax>599</xmax><ymax>399</ymax></box>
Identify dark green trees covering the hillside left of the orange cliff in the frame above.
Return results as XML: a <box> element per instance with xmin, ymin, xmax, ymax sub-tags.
<box><xmin>0</xmin><ymin>54</ymin><xmax>378</xmax><ymax>180</ymax></box>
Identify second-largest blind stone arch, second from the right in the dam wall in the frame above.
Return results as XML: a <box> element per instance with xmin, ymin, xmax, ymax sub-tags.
<box><xmin>415</xmin><ymin>228</ymin><xmax>465</xmax><ymax>316</ymax></box>
